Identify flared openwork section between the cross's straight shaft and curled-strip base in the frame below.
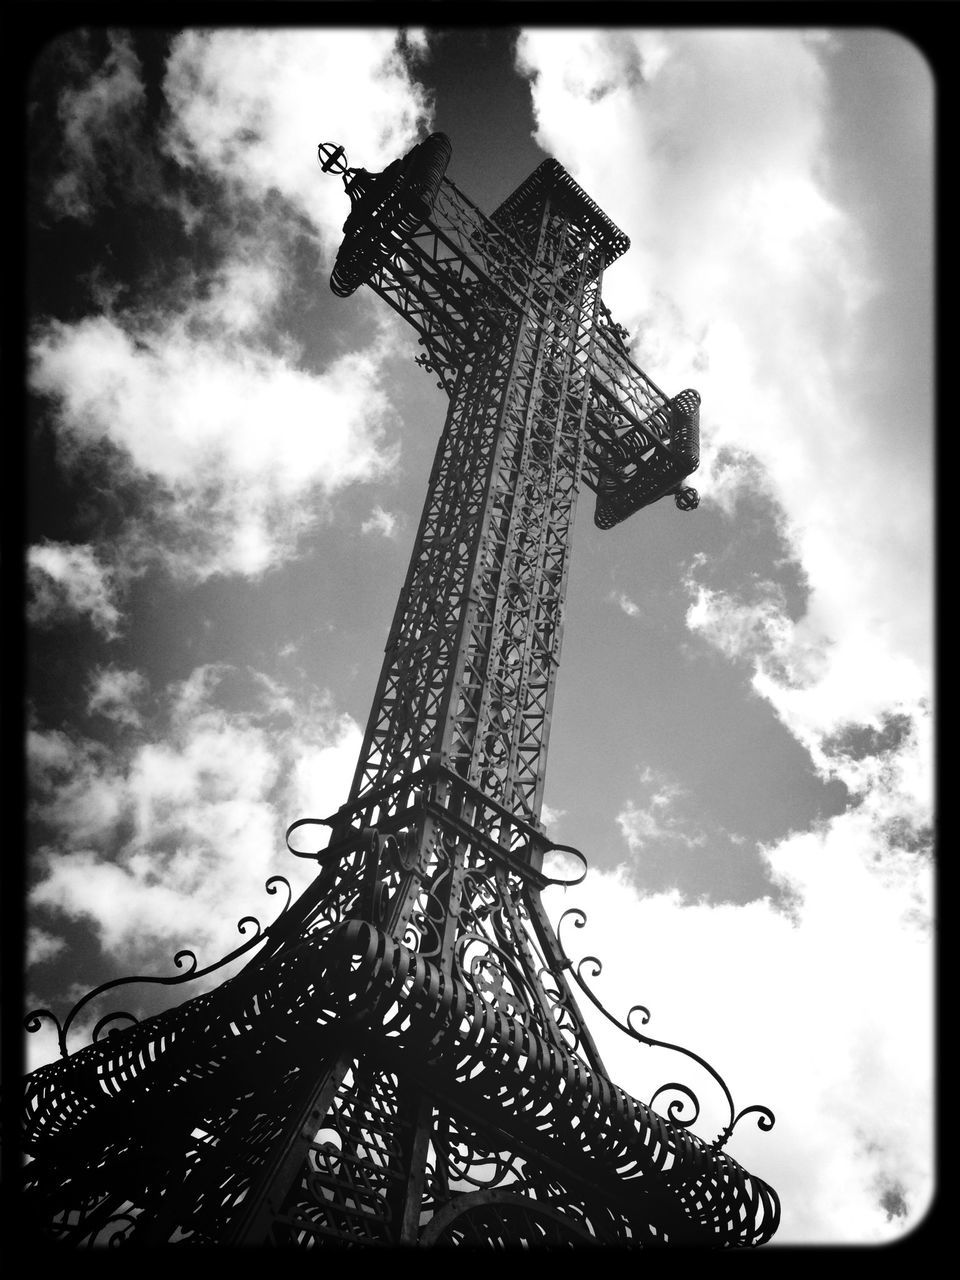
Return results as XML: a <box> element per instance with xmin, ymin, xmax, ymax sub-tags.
<box><xmin>268</xmin><ymin>762</ymin><xmax>603</xmax><ymax>1070</ymax></box>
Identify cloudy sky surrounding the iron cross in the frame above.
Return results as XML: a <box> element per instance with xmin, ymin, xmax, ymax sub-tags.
<box><xmin>18</xmin><ymin>27</ymin><xmax>936</xmax><ymax>1244</ymax></box>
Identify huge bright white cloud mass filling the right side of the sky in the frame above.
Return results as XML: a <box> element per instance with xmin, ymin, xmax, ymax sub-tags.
<box><xmin>518</xmin><ymin>28</ymin><xmax>933</xmax><ymax>1243</ymax></box>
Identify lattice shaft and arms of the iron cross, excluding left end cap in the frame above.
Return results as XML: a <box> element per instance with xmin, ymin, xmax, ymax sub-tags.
<box><xmin>348</xmin><ymin>142</ymin><xmax>699</xmax><ymax>823</ymax></box>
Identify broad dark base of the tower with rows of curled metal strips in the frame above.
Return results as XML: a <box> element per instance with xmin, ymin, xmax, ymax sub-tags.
<box><xmin>28</xmin><ymin>920</ymin><xmax>778</xmax><ymax>1244</ymax></box>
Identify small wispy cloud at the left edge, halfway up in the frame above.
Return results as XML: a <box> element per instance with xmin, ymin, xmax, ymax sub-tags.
<box><xmin>27</xmin><ymin>540</ymin><xmax>120</xmax><ymax>640</ymax></box>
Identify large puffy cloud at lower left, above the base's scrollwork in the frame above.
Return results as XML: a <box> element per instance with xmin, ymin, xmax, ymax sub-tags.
<box><xmin>28</xmin><ymin>666</ymin><xmax>360</xmax><ymax>1034</ymax></box>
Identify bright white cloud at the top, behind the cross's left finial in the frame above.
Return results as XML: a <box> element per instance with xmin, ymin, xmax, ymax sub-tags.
<box><xmin>164</xmin><ymin>28</ymin><xmax>429</xmax><ymax>252</ymax></box>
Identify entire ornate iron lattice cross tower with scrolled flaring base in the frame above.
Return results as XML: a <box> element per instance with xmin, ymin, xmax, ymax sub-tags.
<box><xmin>24</xmin><ymin>133</ymin><xmax>780</xmax><ymax>1247</ymax></box>
